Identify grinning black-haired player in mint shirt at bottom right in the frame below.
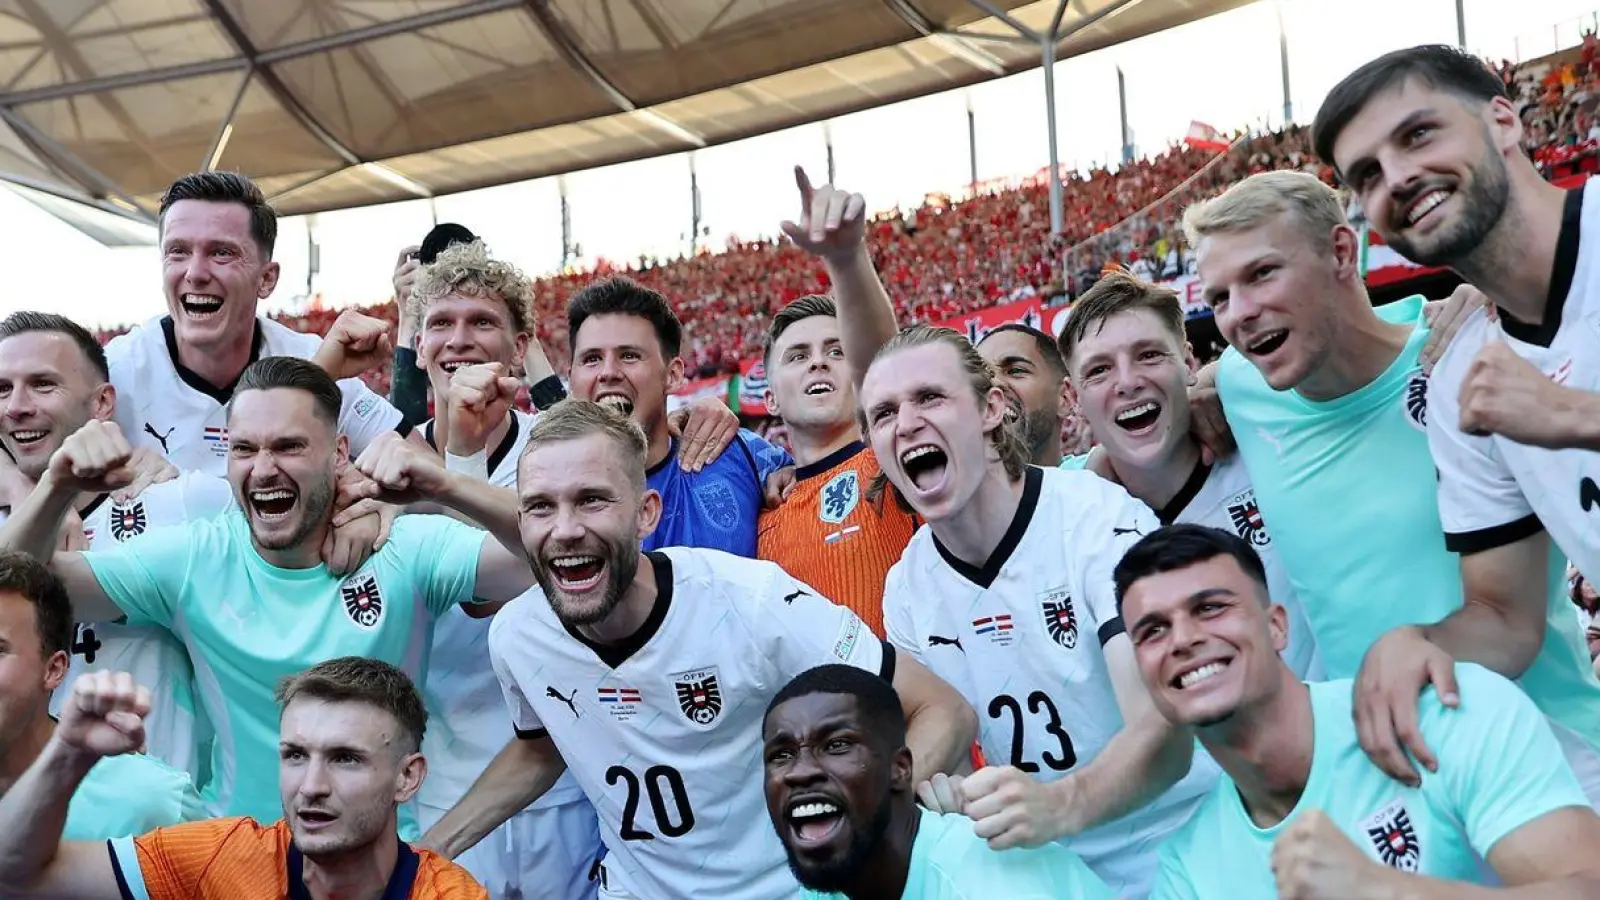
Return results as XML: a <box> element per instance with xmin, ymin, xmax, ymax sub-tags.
<box><xmin>1117</xmin><ymin>525</ymin><xmax>1600</xmax><ymax>900</ymax></box>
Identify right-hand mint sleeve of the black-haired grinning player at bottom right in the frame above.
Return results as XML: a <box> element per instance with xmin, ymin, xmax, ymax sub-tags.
<box><xmin>1419</xmin><ymin>663</ymin><xmax>1589</xmax><ymax>857</ymax></box>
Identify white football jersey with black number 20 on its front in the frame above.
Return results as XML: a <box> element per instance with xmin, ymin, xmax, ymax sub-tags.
<box><xmin>490</xmin><ymin>548</ymin><xmax>894</xmax><ymax>900</ymax></box>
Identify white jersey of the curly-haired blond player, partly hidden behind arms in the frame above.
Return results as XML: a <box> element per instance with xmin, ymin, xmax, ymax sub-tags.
<box><xmin>416</xmin><ymin>412</ymin><xmax>582</xmax><ymax>809</ymax></box>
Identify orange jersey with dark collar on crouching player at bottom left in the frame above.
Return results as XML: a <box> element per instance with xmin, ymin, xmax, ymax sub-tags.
<box><xmin>107</xmin><ymin>818</ymin><xmax>488</xmax><ymax>900</ymax></box>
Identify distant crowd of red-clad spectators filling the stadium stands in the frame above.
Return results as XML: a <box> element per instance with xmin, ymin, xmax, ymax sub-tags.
<box><xmin>90</xmin><ymin>43</ymin><xmax>1600</xmax><ymax>391</ymax></box>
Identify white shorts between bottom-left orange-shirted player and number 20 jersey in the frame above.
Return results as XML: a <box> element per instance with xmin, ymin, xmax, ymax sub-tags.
<box><xmin>416</xmin><ymin>799</ymin><xmax>605</xmax><ymax>900</ymax></box>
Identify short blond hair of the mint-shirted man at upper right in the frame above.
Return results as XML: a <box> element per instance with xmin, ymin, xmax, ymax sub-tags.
<box><xmin>1184</xmin><ymin>170</ymin><xmax>1349</xmax><ymax>250</ymax></box>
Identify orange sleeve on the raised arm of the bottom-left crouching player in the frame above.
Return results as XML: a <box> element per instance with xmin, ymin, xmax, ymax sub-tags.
<box><xmin>133</xmin><ymin>818</ymin><xmax>265</xmax><ymax>900</ymax></box>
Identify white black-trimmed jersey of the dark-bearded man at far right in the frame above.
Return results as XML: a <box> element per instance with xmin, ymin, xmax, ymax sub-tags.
<box><xmin>1427</xmin><ymin>179</ymin><xmax>1600</xmax><ymax>586</ymax></box>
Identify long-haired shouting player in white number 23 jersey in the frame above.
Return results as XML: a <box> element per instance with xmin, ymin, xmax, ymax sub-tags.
<box><xmin>846</xmin><ymin>325</ymin><xmax>1214</xmax><ymax>897</ymax></box>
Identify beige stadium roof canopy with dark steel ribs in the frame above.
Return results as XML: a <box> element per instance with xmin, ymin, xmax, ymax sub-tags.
<box><xmin>0</xmin><ymin>0</ymin><xmax>1248</xmax><ymax>221</ymax></box>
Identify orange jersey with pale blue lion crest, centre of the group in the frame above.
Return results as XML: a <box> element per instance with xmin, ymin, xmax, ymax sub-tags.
<box><xmin>757</xmin><ymin>440</ymin><xmax>917</xmax><ymax>637</ymax></box>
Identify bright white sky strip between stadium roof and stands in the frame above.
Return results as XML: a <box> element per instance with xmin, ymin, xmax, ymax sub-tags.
<box><xmin>12</xmin><ymin>0</ymin><xmax>1600</xmax><ymax>325</ymax></box>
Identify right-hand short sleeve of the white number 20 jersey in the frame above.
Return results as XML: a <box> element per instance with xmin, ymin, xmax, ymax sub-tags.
<box><xmin>734</xmin><ymin>562</ymin><xmax>894</xmax><ymax>681</ymax></box>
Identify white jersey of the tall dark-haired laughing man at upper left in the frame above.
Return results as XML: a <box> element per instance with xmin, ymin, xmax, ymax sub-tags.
<box><xmin>106</xmin><ymin>315</ymin><xmax>402</xmax><ymax>476</ymax></box>
